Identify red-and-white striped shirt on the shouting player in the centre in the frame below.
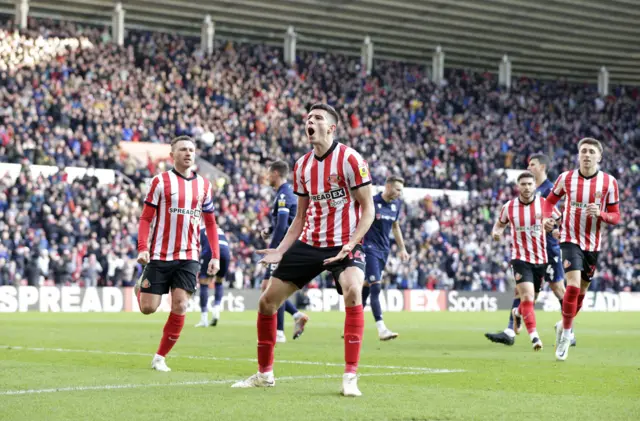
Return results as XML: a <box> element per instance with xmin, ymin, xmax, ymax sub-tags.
<box><xmin>293</xmin><ymin>142</ymin><xmax>371</xmax><ymax>247</ymax></box>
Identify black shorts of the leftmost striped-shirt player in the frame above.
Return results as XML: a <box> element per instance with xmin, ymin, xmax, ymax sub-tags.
<box><xmin>140</xmin><ymin>260</ymin><xmax>200</xmax><ymax>295</ymax></box>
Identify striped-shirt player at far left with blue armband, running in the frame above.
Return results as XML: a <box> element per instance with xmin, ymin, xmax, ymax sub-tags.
<box><xmin>135</xmin><ymin>136</ymin><xmax>220</xmax><ymax>371</ymax></box>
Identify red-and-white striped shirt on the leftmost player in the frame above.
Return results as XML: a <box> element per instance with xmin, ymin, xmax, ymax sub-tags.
<box><xmin>144</xmin><ymin>170</ymin><xmax>213</xmax><ymax>261</ymax></box>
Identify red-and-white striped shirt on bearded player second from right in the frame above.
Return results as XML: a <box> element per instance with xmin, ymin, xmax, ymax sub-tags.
<box><xmin>500</xmin><ymin>197</ymin><xmax>560</xmax><ymax>265</ymax></box>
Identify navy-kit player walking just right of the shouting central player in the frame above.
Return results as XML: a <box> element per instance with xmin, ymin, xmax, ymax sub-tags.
<box><xmin>362</xmin><ymin>176</ymin><xmax>409</xmax><ymax>341</ymax></box>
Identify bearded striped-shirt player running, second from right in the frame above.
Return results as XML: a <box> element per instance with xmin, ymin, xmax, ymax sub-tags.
<box><xmin>491</xmin><ymin>171</ymin><xmax>560</xmax><ymax>351</ymax></box>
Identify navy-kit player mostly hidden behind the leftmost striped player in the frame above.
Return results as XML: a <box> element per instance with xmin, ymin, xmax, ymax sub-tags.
<box><xmin>196</xmin><ymin>227</ymin><xmax>231</xmax><ymax>327</ymax></box>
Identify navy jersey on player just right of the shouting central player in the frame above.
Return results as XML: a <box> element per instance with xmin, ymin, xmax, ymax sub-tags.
<box><xmin>364</xmin><ymin>193</ymin><xmax>402</xmax><ymax>256</ymax></box>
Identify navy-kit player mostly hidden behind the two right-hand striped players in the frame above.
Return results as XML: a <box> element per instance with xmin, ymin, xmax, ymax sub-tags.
<box><xmin>485</xmin><ymin>154</ymin><xmax>576</xmax><ymax>346</ymax></box>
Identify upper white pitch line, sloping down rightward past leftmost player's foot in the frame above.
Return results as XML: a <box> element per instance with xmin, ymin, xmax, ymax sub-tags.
<box><xmin>0</xmin><ymin>345</ymin><xmax>464</xmax><ymax>373</ymax></box>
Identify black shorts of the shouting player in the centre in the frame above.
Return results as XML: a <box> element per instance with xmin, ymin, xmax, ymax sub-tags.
<box><xmin>271</xmin><ymin>240</ymin><xmax>365</xmax><ymax>294</ymax></box>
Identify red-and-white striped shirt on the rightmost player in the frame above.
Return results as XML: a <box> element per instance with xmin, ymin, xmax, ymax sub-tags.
<box><xmin>553</xmin><ymin>170</ymin><xmax>620</xmax><ymax>251</ymax></box>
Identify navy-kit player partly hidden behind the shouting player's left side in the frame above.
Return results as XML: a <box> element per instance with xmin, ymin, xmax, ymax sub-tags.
<box><xmin>261</xmin><ymin>161</ymin><xmax>309</xmax><ymax>343</ymax></box>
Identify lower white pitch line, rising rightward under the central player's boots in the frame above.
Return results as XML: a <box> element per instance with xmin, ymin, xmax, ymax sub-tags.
<box><xmin>0</xmin><ymin>370</ymin><xmax>455</xmax><ymax>396</ymax></box>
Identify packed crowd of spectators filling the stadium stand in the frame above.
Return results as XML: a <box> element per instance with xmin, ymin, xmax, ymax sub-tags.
<box><xmin>0</xmin><ymin>20</ymin><xmax>640</xmax><ymax>291</ymax></box>
